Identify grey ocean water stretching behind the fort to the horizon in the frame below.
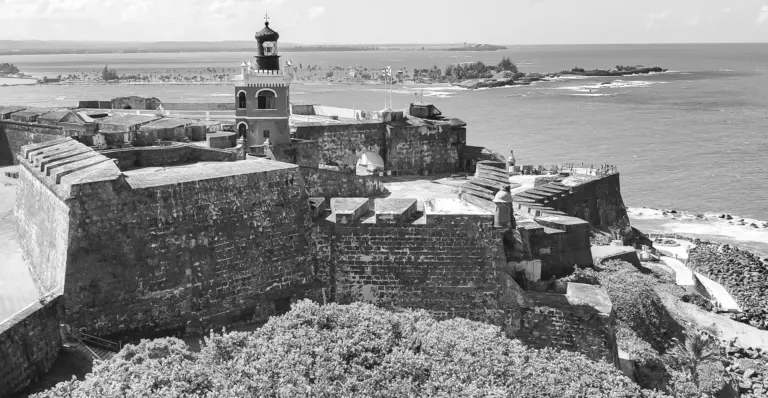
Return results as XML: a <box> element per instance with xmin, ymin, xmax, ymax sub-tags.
<box><xmin>0</xmin><ymin>44</ymin><xmax>768</xmax><ymax>252</ymax></box>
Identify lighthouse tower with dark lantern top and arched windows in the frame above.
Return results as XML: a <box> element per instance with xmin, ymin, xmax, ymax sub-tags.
<box><xmin>232</xmin><ymin>17</ymin><xmax>292</xmax><ymax>148</ymax></box>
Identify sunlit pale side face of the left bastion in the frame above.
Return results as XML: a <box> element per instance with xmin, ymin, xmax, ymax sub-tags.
<box><xmin>14</xmin><ymin>163</ymin><xmax>70</xmax><ymax>294</ymax></box>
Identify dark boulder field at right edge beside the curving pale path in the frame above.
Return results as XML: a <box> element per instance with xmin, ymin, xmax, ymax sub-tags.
<box><xmin>688</xmin><ymin>243</ymin><xmax>768</xmax><ymax>330</ymax></box>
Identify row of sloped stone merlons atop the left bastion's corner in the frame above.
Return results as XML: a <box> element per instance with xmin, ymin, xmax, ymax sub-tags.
<box><xmin>18</xmin><ymin>138</ymin><xmax>123</xmax><ymax>199</ymax></box>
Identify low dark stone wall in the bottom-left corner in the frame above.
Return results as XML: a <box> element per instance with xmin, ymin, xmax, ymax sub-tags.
<box><xmin>0</xmin><ymin>296</ymin><xmax>63</xmax><ymax>397</ymax></box>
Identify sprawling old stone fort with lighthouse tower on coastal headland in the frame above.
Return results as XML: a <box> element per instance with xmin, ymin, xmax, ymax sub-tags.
<box><xmin>0</xmin><ymin>19</ymin><xmax>631</xmax><ymax>396</ymax></box>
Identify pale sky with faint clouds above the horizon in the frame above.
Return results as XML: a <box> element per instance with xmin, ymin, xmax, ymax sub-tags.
<box><xmin>0</xmin><ymin>0</ymin><xmax>768</xmax><ymax>45</ymax></box>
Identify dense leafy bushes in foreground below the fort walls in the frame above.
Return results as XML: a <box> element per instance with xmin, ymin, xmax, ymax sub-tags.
<box><xmin>38</xmin><ymin>301</ymin><xmax>641</xmax><ymax>397</ymax></box>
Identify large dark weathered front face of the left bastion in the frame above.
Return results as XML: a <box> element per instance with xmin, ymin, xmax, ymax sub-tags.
<box><xmin>65</xmin><ymin>167</ymin><xmax>317</xmax><ymax>339</ymax></box>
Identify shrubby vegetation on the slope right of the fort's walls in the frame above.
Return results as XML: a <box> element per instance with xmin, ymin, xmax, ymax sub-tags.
<box><xmin>592</xmin><ymin>261</ymin><xmax>730</xmax><ymax>397</ymax></box>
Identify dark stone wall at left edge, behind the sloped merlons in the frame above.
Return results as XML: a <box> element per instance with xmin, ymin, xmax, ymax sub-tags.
<box><xmin>0</xmin><ymin>120</ymin><xmax>65</xmax><ymax>166</ymax></box>
